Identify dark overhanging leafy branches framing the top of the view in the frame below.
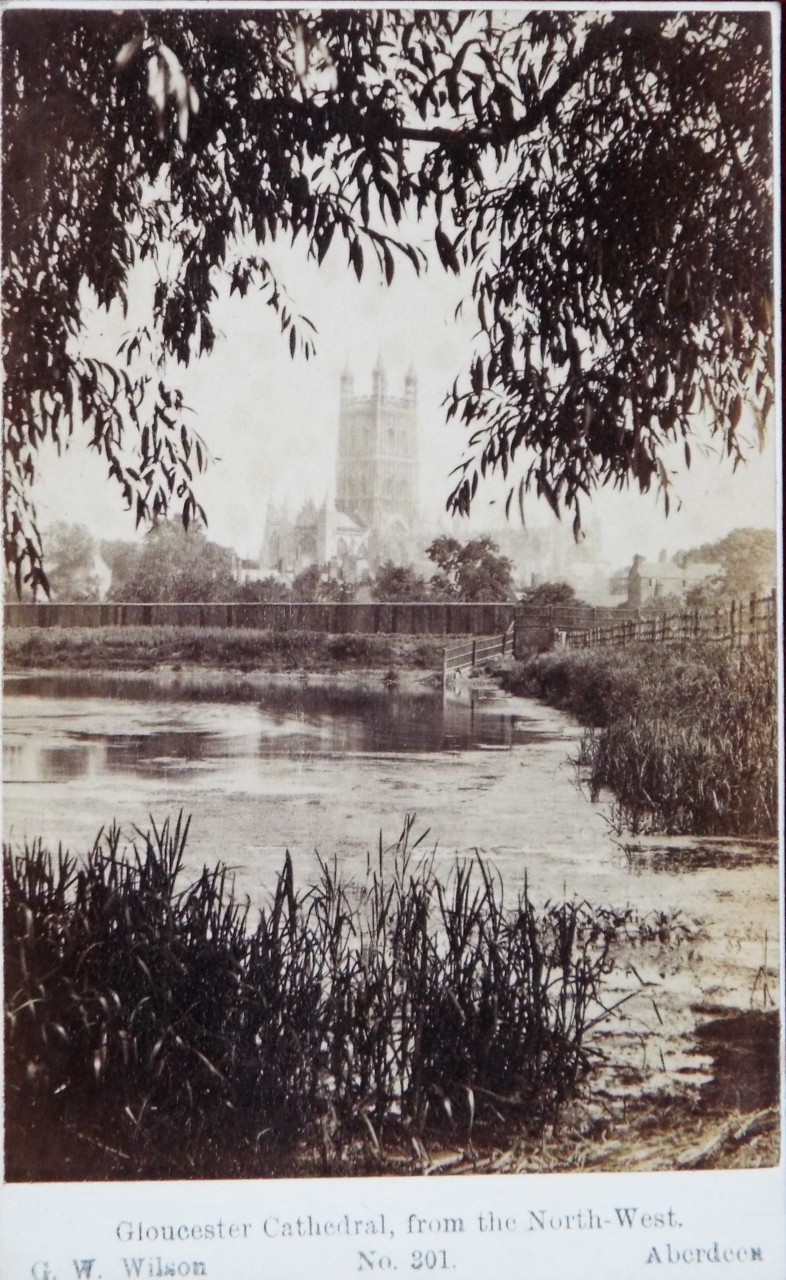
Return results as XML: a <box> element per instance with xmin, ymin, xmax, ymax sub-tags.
<box><xmin>3</xmin><ymin>6</ymin><xmax>773</xmax><ymax>591</ymax></box>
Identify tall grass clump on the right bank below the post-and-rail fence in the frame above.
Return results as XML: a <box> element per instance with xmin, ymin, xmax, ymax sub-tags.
<box><xmin>503</xmin><ymin>644</ymin><xmax>778</xmax><ymax>836</ymax></box>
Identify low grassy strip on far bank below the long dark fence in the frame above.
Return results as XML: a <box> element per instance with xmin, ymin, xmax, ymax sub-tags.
<box><xmin>4</xmin><ymin>627</ymin><xmax>443</xmax><ymax>672</ymax></box>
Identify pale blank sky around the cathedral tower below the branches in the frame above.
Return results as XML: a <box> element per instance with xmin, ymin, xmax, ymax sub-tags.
<box><xmin>33</xmin><ymin>229</ymin><xmax>780</xmax><ymax>566</ymax></box>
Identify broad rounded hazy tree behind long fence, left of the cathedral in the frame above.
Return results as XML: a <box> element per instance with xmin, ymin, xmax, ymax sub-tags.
<box><xmin>102</xmin><ymin>520</ymin><xmax>236</xmax><ymax>603</ymax></box>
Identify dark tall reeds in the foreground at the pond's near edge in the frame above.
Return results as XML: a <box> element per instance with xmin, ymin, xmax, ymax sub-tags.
<box><xmin>4</xmin><ymin>819</ymin><xmax>618</xmax><ymax>1179</ymax></box>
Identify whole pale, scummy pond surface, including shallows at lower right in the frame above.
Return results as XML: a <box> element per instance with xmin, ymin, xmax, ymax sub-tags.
<box><xmin>3</xmin><ymin>676</ymin><xmax>778</xmax><ymax>1111</ymax></box>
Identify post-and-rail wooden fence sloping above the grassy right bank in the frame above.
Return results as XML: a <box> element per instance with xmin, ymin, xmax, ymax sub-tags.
<box><xmin>558</xmin><ymin>591</ymin><xmax>778</xmax><ymax>649</ymax></box>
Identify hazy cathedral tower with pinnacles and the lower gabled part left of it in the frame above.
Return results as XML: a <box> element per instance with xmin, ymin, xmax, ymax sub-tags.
<box><xmin>262</xmin><ymin>360</ymin><xmax>419</xmax><ymax>581</ymax></box>
